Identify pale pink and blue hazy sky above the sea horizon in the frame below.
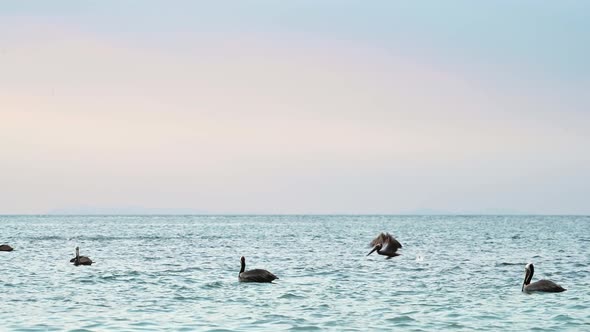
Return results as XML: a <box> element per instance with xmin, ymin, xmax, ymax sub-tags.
<box><xmin>0</xmin><ymin>0</ymin><xmax>590</xmax><ymax>214</ymax></box>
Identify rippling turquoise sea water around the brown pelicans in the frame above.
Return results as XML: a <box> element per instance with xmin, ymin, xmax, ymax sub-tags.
<box><xmin>0</xmin><ymin>216</ymin><xmax>590</xmax><ymax>331</ymax></box>
